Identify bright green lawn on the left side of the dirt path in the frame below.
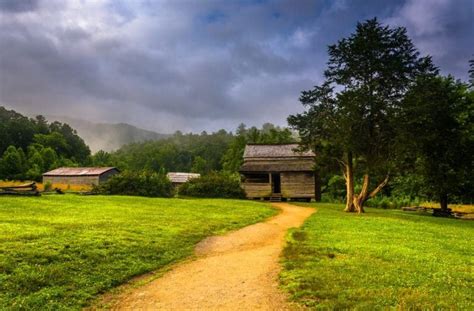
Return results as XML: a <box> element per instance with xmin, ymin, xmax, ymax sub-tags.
<box><xmin>0</xmin><ymin>195</ymin><xmax>275</xmax><ymax>310</ymax></box>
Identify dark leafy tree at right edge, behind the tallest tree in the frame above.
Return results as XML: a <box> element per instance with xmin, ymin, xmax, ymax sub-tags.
<box><xmin>398</xmin><ymin>77</ymin><xmax>474</xmax><ymax>214</ymax></box>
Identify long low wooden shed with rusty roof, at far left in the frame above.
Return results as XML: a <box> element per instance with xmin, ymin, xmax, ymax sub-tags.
<box><xmin>43</xmin><ymin>167</ymin><xmax>120</xmax><ymax>185</ymax></box>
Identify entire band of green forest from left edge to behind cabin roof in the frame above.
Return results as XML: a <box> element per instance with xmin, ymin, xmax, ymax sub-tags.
<box><xmin>0</xmin><ymin>107</ymin><xmax>296</xmax><ymax>185</ymax></box>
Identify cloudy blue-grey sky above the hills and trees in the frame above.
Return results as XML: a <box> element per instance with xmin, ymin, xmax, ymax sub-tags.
<box><xmin>0</xmin><ymin>0</ymin><xmax>474</xmax><ymax>133</ymax></box>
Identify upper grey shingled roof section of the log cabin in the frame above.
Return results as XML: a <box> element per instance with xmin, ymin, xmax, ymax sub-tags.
<box><xmin>244</xmin><ymin>144</ymin><xmax>314</xmax><ymax>158</ymax></box>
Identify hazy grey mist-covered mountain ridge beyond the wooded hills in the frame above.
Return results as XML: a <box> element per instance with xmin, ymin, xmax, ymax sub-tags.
<box><xmin>45</xmin><ymin>116</ymin><xmax>170</xmax><ymax>153</ymax></box>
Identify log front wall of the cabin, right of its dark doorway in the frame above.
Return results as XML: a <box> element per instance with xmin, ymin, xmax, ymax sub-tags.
<box><xmin>280</xmin><ymin>172</ymin><xmax>315</xmax><ymax>198</ymax></box>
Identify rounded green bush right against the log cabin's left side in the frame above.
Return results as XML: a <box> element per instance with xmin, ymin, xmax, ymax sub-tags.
<box><xmin>179</xmin><ymin>173</ymin><xmax>245</xmax><ymax>199</ymax></box>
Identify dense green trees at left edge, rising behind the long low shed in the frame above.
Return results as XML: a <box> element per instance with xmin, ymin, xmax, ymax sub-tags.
<box><xmin>0</xmin><ymin>107</ymin><xmax>90</xmax><ymax>180</ymax></box>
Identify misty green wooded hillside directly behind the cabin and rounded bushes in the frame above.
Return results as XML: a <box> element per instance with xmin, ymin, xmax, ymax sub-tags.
<box><xmin>91</xmin><ymin>123</ymin><xmax>296</xmax><ymax>174</ymax></box>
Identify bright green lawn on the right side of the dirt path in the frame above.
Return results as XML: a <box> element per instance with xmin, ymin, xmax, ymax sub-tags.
<box><xmin>280</xmin><ymin>204</ymin><xmax>474</xmax><ymax>310</ymax></box>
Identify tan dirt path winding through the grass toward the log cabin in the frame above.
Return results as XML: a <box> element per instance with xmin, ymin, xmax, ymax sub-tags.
<box><xmin>112</xmin><ymin>203</ymin><xmax>314</xmax><ymax>310</ymax></box>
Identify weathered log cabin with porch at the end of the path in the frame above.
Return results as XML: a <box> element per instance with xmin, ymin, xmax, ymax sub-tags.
<box><xmin>240</xmin><ymin>144</ymin><xmax>315</xmax><ymax>201</ymax></box>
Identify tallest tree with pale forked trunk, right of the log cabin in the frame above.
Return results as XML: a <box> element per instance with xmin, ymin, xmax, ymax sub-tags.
<box><xmin>288</xmin><ymin>18</ymin><xmax>437</xmax><ymax>213</ymax></box>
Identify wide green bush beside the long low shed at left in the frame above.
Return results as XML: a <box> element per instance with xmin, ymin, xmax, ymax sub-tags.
<box><xmin>92</xmin><ymin>172</ymin><xmax>173</xmax><ymax>197</ymax></box>
